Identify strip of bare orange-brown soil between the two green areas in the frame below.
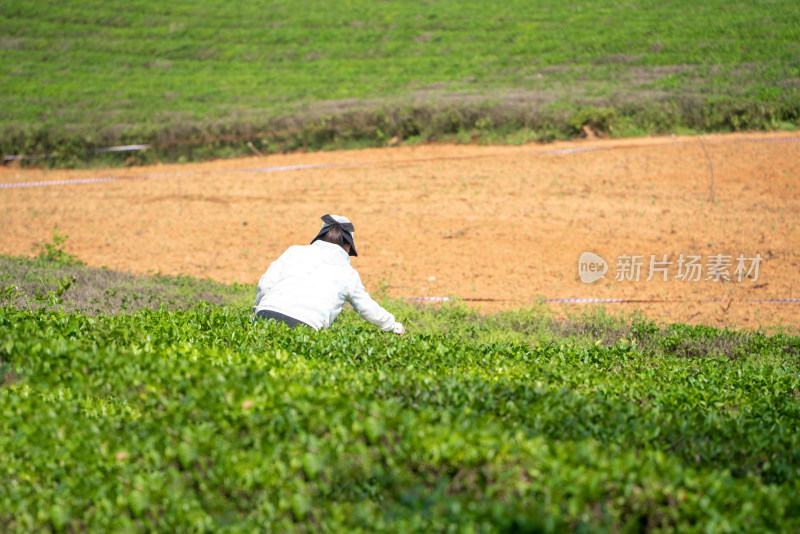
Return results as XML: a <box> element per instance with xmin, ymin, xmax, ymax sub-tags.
<box><xmin>0</xmin><ymin>132</ymin><xmax>800</xmax><ymax>330</ymax></box>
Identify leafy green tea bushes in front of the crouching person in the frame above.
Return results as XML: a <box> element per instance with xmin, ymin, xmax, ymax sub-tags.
<box><xmin>0</xmin><ymin>305</ymin><xmax>800</xmax><ymax>532</ymax></box>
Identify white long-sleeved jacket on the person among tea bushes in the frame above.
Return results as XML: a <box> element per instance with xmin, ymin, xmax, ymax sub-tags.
<box><xmin>253</xmin><ymin>241</ymin><xmax>403</xmax><ymax>334</ymax></box>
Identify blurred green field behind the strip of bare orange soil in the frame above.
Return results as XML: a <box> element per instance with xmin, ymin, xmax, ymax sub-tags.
<box><xmin>0</xmin><ymin>0</ymin><xmax>800</xmax><ymax>164</ymax></box>
